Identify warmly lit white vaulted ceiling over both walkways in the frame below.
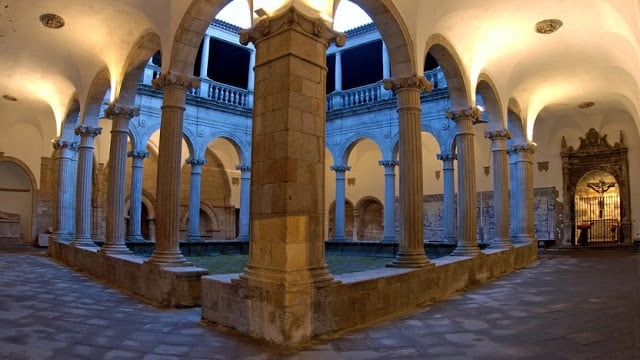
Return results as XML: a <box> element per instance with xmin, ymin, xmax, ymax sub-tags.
<box><xmin>0</xmin><ymin>0</ymin><xmax>640</xmax><ymax>151</ymax></box>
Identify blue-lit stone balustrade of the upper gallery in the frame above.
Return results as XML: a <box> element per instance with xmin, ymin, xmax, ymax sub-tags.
<box><xmin>140</xmin><ymin>63</ymin><xmax>447</xmax><ymax>111</ymax></box>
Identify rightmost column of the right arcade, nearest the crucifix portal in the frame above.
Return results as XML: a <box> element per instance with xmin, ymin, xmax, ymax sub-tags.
<box><xmin>509</xmin><ymin>143</ymin><xmax>536</xmax><ymax>244</ymax></box>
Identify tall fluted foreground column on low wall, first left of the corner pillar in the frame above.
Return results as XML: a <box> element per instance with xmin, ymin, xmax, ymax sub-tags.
<box><xmin>149</xmin><ymin>72</ymin><xmax>199</xmax><ymax>265</ymax></box>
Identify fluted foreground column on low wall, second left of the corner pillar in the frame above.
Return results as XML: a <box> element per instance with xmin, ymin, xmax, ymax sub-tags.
<box><xmin>100</xmin><ymin>104</ymin><xmax>139</xmax><ymax>254</ymax></box>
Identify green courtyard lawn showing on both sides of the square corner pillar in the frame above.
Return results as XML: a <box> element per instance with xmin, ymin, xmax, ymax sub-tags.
<box><xmin>187</xmin><ymin>254</ymin><xmax>392</xmax><ymax>275</ymax></box>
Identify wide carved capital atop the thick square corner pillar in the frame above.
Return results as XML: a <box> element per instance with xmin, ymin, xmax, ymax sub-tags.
<box><xmin>240</xmin><ymin>6</ymin><xmax>346</xmax><ymax>47</ymax></box>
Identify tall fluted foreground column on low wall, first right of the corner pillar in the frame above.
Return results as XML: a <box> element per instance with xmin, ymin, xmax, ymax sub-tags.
<box><xmin>383</xmin><ymin>75</ymin><xmax>433</xmax><ymax>267</ymax></box>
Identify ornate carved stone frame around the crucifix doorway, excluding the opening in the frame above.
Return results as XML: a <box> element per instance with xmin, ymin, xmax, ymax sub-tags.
<box><xmin>560</xmin><ymin>128</ymin><xmax>631</xmax><ymax>246</ymax></box>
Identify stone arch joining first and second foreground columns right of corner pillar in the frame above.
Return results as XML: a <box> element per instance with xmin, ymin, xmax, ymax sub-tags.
<box><xmin>424</xmin><ymin>34</ymin><xmax>475</xmax><ymax>108</ymax></box>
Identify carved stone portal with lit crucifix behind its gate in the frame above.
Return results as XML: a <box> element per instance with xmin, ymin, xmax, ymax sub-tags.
<box><xmin>560</xmin><ymin>128</ymin><xmax>631</xmax><ymax>246</ymax></box>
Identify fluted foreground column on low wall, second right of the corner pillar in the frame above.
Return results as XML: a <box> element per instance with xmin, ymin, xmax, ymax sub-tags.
<box><xmin>447</xmin><ymin>108</ymin><xmax>480</xmax><ymax>256</ymax></box>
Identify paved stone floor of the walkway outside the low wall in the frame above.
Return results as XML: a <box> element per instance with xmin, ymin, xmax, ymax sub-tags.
<box><xmin>0</xmin><ymin>246</ymin><xmax>640</xmax><ymax>360</ymax></box>
